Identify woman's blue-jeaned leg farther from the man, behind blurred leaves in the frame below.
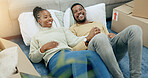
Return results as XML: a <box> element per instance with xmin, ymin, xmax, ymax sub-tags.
<box><xmin>49</xmin><ymin>50</ymin><xmax>87</xmax><ymax>78</ymax></box>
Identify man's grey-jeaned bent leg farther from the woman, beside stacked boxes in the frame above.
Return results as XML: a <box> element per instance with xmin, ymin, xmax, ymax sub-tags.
<box><xmin>110</xmin><ymin>25</ymin><xmax>142</xmax><ymax>78</ymax></box>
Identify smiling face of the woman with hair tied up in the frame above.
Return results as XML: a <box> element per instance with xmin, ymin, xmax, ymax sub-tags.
<box><xmin>38</xmin><ymin>10</ymin><xmax>53</xmax><ymax>28</ymax></box>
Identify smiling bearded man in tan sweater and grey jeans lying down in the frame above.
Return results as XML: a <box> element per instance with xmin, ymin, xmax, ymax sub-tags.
<box><xmin>70</xmin><ymin>3</ymin><xmax>142</xmax><ymax>78</ymax></box>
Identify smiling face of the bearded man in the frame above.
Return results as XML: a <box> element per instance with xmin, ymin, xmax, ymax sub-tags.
<box><xmin>72</xmin><ymin>5</ymin><xmax>86</xmax><ymax>23</ymax></box>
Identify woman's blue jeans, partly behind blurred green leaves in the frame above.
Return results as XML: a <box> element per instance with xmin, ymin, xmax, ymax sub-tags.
<box><xmin>49</xmin><ymin>50</ymin><xmax>110</xmax><ymax>78</ymax></box>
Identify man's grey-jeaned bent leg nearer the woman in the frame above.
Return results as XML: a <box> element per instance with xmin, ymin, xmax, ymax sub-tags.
<box><xmin>88</xmin><ymin>33</ymin><xmax>124</xmax><ymax>78</ymax></box>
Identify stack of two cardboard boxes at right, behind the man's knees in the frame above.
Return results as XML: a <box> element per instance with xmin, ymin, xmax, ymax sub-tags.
<box><xmin>111</xmin><ymin>0</ymin><xmax>148</xmax><ymax>47</ymax></box>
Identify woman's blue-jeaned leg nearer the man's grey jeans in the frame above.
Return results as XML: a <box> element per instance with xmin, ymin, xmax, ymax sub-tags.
<box><xmin>78</xmin><ymin>50</ymin><xmax>110</xmax><ymax>78</ymax></box>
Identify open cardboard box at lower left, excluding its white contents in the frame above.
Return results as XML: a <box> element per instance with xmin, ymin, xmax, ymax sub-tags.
<box><xmin>0</xmin><ymin>38</ymin><xmax>40</xmax><ymax>78</ymax></box>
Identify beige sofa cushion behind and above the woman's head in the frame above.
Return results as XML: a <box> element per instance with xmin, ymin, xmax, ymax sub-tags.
<box><xmin>8</xmin><ymin>0</ymin><xmax>60</xmax><ymax>20</ymax></box>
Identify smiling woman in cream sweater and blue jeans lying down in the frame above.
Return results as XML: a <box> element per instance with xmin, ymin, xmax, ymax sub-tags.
<box><xmin>29</xmin><ymin>7</ymin><xmax>110</xmax><ymax>78</ymax></box>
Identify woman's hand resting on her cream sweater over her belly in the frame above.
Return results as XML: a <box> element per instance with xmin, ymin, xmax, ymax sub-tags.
<box><xmin>40</xmin><ymin>41</ymin><xmax>58</xmax><ymax>53</ymax></box>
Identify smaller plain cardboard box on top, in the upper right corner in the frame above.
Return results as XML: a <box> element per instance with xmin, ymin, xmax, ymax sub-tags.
<box><xmin>133</xmin><ymin>0</ymin><xmax>148</xmax><ymax>18</ymax></box>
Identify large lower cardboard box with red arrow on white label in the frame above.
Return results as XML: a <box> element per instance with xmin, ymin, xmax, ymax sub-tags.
<box><xmin>111</xmin><ymin>1</ymin><xmax>148</xmax><ymax>47</ymax></box>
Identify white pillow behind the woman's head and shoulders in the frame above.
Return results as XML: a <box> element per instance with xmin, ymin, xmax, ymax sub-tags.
<box><xmin>18</xmin><ymin>10</ymin><xmax>64</xmax><ymax>46</ymax></box>
